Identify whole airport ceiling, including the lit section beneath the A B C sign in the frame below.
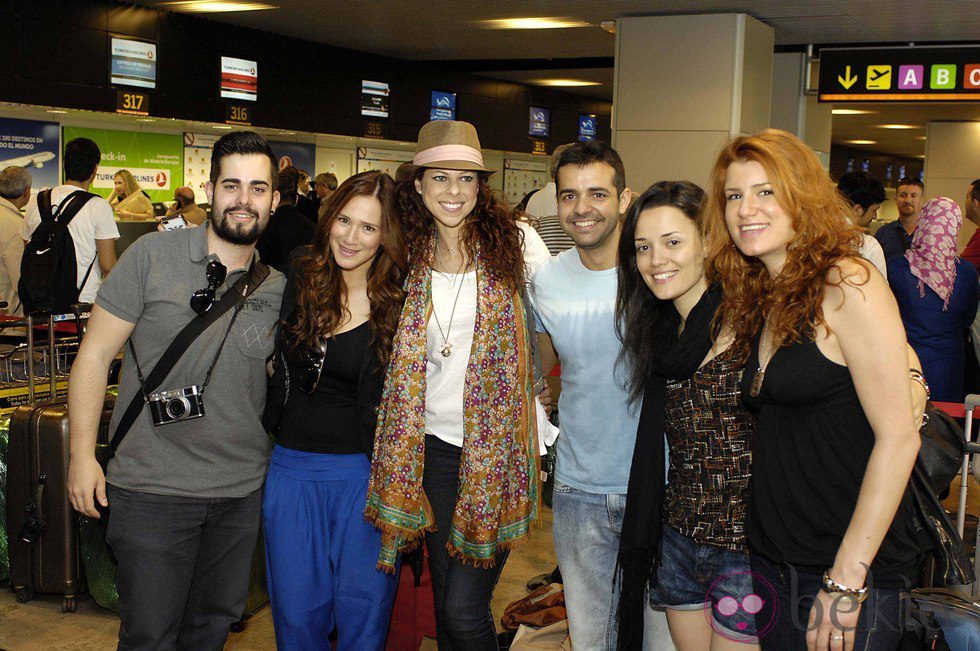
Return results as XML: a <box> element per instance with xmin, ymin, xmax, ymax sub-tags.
<box><xmin>130</xmin><ymin>0</ymin><xmax>980</xmax><ymax>156</ymax></box>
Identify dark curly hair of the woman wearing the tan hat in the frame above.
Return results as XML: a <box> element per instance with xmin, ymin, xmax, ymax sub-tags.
<box><xmin>398</xmin><ymin>168</ymin><xmax>524</xmax><ymax>290</ymax></box>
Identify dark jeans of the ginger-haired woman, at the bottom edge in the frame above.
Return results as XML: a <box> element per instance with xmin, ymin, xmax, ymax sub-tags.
<box><xmin>751</xmin><ymin>554</ymin><xmax>902</xmax><ymax>651</ymax></box>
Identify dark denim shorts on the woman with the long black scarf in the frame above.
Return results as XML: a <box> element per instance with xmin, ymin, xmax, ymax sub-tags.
<box><xmin>650</xmin><ymin>527</ymin><xmax>763</xmax><ymax>643</ymax></box>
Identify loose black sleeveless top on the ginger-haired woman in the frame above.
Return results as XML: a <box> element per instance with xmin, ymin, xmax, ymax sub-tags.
<box><xmin>742</xmin><ymin>339</ymin><xmax>925</xmax><ymax>588</ymax></box>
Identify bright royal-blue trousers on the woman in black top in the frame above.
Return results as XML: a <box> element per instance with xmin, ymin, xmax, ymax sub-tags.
<box><xmin>262</xmin><ymin>445</ymin><xmax>396</xmax><ymax>651</ymax></box>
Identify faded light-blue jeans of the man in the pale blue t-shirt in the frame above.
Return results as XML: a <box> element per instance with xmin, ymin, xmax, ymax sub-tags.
<box><xmin>552</xmin><ymin>480</ymin><xmax>674</xmax><ymax>651</ymax></box>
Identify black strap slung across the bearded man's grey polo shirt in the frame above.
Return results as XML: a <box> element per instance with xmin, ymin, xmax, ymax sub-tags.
<box><xmin>109</xmin><ymin>260</ymin><xmax>269</xmax><ymax>458</ymax></box>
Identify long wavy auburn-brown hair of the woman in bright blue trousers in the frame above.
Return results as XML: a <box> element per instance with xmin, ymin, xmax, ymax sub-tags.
<box><xmin>290</xmin><ymin>170</ymin><xmax>408</xmax><ymax>363</ymax></box>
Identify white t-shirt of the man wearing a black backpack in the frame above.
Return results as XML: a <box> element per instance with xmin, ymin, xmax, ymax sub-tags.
<box><xmin>21</xmin><ymin>185</ymin><xmax>119</xmax><ymax>303</ymax></box>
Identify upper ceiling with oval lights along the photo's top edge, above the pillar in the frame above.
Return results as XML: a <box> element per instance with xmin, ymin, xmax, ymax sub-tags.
<box><xmin>136</xmin><ymin>0</ymin><xmax>980</xmax><ymax>61</ymax></box>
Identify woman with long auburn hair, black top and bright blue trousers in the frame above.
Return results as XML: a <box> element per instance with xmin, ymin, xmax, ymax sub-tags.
<box><xmin>262</xmin><ymin>170</ymin><xmax>406</xmax><ymax>651</ymax></box>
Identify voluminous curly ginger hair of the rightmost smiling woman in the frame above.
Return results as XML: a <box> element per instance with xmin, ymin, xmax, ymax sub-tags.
<box><xmin>704</xmin><ymin>129</ymin><xmax>868</xmax><ymax>362</ymax></box>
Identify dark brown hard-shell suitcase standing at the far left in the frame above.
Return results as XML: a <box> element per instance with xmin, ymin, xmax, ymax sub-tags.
<box><xmin>7</xmin><ymin>396</ymin><xmax>115</xmax><ymax>612</ymax></box>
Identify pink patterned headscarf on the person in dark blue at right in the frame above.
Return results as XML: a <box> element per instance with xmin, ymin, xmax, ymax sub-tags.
<box><xmin>905</xmin><ymin>197</ymin><xmax>963</xmax><ymax>311</ymax></box>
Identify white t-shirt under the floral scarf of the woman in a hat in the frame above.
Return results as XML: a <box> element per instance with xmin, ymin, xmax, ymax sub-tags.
<box><xmin>425</xmin><ymin>271</ymin><xmax>476</xmax><ymax>448</ymax></box>
